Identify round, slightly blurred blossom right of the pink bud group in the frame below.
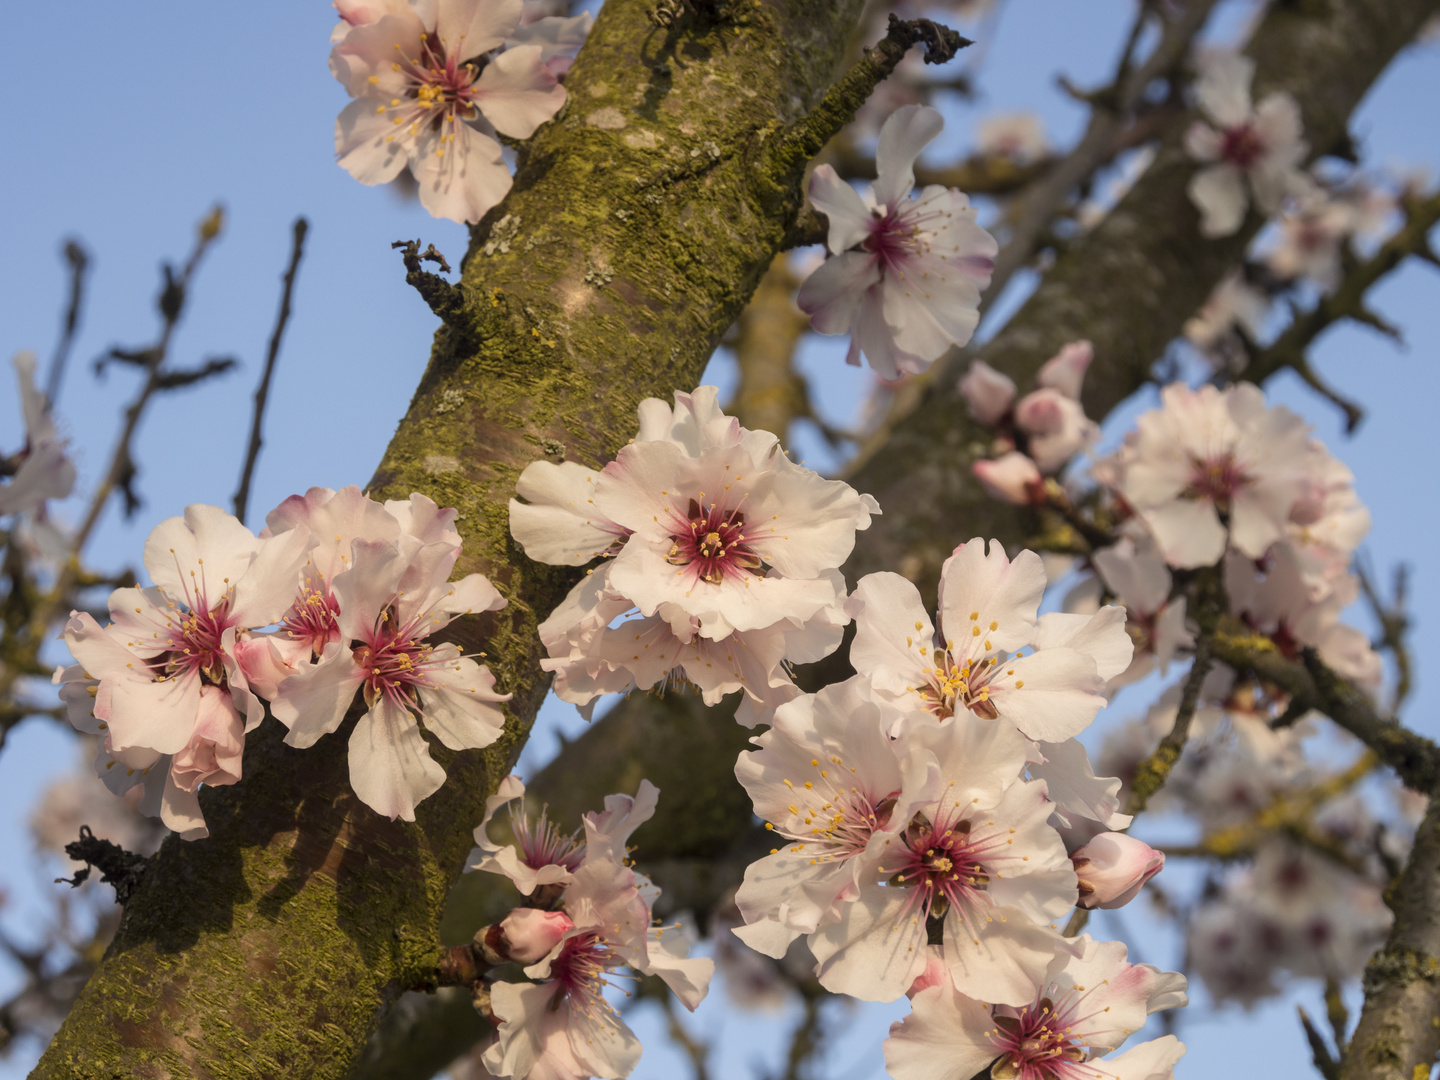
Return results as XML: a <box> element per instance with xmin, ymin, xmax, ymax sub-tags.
<box><xmin>1113</xmin><ymin>383</ymin><xmax>1310</xmax><ymax>569</ymax></box>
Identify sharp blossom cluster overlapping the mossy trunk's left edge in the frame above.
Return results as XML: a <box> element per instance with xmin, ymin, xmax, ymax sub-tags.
<box><xmin>55</xmin><ymin>487</ymin><xmax>508</xmax><ymax>840</ymax></box>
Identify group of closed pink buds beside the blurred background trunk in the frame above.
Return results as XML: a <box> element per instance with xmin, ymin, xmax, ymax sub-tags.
<box><xmin>960</xmin><ymin>341</ymin><xmax>1100</xmax><ymax>505</ymax></box>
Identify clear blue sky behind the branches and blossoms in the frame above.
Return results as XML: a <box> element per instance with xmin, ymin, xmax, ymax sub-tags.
<box><xmin>0</xmin><ymin>0</ymin><xmax>1440</xmax><ymax>1080</ymax></box>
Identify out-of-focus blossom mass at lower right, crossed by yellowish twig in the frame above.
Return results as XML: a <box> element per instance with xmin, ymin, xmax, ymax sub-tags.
<box><xmin>1099</xmin><ymin>668</ymin><xmax>1416</xmax><ymax>1005</ymax></box>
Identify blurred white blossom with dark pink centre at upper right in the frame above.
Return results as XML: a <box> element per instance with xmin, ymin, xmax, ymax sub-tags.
<box><xmin>1185</xmin><ymin>55</ymin><xmax>1310</xmax><ymax>236</ymax></box>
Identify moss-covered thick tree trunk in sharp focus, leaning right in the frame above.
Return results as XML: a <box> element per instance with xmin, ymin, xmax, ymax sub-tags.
<box><xmin>33</xmin><ymin>0</ymin><xmax>860</xmax><ymax>1080</ymax></box>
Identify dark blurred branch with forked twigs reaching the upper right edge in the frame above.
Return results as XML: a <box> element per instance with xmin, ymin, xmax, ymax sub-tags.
<box><xmin>1244</xmin><ymin>190</ymin><xmax>1440</xmax><ymax>431</ymax></box>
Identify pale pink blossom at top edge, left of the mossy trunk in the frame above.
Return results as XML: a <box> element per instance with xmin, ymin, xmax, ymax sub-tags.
<box><xmin>330</xmin><ymin>0</ymin><xmax>564</xmax><ymax>223</ymax></box>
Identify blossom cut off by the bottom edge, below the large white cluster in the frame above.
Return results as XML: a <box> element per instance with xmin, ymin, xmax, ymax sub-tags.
<box><xmin>884</xmin><ymin>936</ymin><xmax>1188</xmax><ymax>1080</ymax></box>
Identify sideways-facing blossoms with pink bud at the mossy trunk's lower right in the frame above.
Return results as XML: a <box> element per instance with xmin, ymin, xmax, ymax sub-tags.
<box><xmin>469</xmin><ymin>776</ymin><xmax>714</xmax><ymax>1080</ymax></box>
